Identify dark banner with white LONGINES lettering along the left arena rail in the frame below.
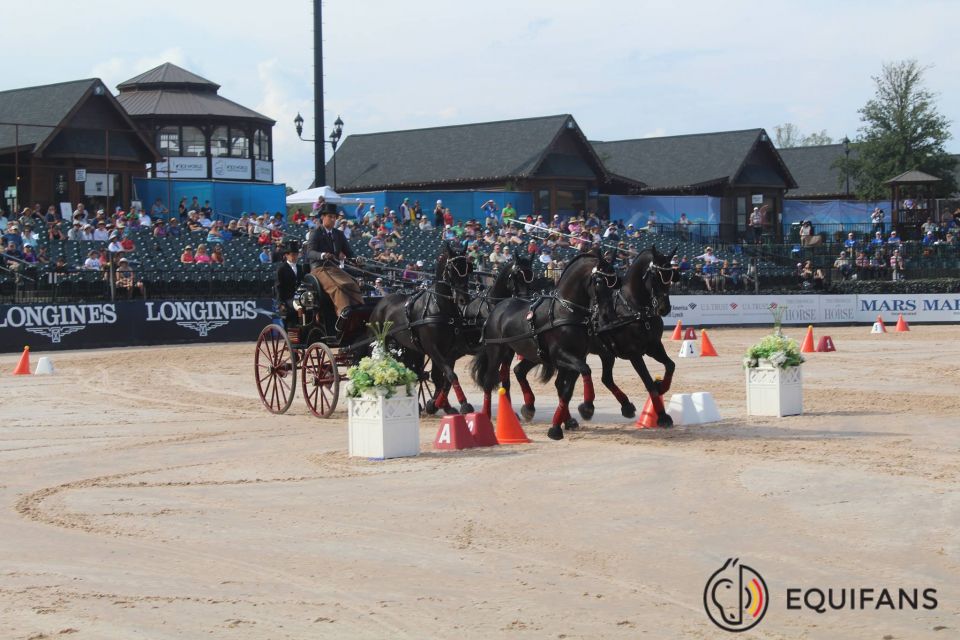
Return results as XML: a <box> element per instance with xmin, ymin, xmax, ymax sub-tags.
<box><xmin>0</xmin><ymin>300</ymin><xmax>274</xmax><ymax>352</ymax></box>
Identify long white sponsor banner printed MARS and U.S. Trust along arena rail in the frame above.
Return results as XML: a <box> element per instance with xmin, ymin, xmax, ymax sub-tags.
<box><xmin>670</xmin><ymin>293</ymin><xmax>960</xmax><ymax>326</ymax></box>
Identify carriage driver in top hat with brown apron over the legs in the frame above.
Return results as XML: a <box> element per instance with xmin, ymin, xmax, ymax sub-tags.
<box><xmin>304</xmin><ymin>204</ymin><xmax>363</xmax><ymax>316</ymax></box>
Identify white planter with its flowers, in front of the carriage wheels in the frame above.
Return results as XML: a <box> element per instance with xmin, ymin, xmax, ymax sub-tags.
<box><xmin>347</xmin><ymin>322</ymin><xmax>420</xmax><ymax>460</ymax></box>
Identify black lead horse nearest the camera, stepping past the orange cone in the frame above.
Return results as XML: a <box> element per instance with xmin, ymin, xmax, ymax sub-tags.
<box><xmin>471</xmin><ymin>252</ymin><xmax>616</xmax><ymax>440</ymax></box>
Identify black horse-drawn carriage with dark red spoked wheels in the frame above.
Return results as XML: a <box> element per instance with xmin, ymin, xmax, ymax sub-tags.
<box><xmin>254</xmin><ymin>274</ymin><xmax>434</xmax><ymax>418</ymax></box>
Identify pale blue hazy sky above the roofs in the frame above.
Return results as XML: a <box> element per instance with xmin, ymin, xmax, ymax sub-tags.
<box><xmin>0</xmin><ymin>0</ymin><xmax>960</xmax><ymax>189</ymax></box>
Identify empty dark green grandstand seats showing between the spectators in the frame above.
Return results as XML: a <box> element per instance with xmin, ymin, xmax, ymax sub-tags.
<box><xmin>0</xmin><ymin>216</ymin><xmax>960</xmax><ymax>302</ymax></box>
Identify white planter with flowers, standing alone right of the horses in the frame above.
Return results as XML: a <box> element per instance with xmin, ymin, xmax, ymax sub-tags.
<box><xmin>743</xmin><ymin>305</ymin><xmax>805</xmax><ymax>416</ymax></box>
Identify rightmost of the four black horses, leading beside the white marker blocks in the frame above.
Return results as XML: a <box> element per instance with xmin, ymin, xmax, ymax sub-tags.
<box><xmin>579</xmin><ymin>246</ymin><xmax>676</xmax><ymax>427</ymax></box>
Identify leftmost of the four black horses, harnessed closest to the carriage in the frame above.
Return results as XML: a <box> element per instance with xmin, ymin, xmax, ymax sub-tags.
<box><xmin>370</xmin><ymin>243</ymin><xmax>473</xmax><ymax>413</ymax></box>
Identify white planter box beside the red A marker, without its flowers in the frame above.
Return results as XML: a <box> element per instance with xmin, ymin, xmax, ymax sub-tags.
<box><xmin>347</xmin><ymin>387</ymin><xmax>420</xmax><ymax>460</ymax></box>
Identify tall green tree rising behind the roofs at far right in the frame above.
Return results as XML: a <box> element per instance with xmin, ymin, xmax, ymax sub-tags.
<box><xmin>834</xmin><ymin>60</ymin><xmax>957</xmax><ymax>200</ymax></box>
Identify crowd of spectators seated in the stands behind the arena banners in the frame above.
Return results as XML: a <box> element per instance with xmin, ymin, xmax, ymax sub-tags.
<box><xmin>0</xmin><ymin>198</ymin><xmax>960</xmax><ymax>293</ymax></box>
